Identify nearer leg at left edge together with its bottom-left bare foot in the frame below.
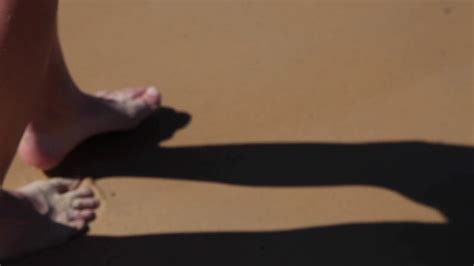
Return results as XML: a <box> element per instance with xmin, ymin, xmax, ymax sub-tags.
<box><xmin>0</xmin><ymin>0</ymin><xmax>98</xmax><ymax>261</ymax></box>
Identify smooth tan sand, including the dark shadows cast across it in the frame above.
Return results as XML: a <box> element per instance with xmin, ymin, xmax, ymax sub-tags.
<box><xmin>6</xmin><ymin>0</ymin><xmax>474</xmax><ymax>266</ymax></box>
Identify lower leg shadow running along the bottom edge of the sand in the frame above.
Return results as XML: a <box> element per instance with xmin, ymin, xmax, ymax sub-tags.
<box><xmin>15</xmin><ymin>223</ymin><xmax>472</xmax><ymax>266</ymax></box>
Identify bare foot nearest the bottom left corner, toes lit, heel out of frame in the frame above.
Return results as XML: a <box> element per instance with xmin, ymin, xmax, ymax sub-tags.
<box><xmin>0</xmin><ymin>178</ymin><xmax>99</xmax><ymax>260</ymax></box>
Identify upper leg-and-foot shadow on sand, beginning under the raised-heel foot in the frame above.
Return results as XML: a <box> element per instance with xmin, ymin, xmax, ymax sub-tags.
<box><xmin>48</xmin><ymin>108</ymin><xmax>474</xmax><ymax>224</ymax></box>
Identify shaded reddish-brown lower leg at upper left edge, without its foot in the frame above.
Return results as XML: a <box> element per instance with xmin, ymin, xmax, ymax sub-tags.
<box><xmin>0</xmin><ymin>0</ymin><xmax>57</xmax><ymax>184</ymax></box>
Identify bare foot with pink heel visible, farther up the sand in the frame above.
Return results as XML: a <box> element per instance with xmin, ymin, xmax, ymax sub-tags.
<box><xmin>18</xmin><ymin>87</ymin><xmax>161</xmax><ymax>170</ymax></box>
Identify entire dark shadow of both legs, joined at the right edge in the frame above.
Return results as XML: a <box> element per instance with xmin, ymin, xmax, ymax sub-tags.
<box><xmin>12</xmin><ymin>108</ymin><xmax>474</xmax><ymax>265</ymax></box>
